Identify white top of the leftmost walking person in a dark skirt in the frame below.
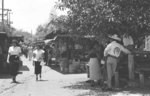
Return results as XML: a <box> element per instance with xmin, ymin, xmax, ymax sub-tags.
<box><xmin>8</xmin><ymin>46</ymin><xmax>21</xmax><ymax>55</ymax></box>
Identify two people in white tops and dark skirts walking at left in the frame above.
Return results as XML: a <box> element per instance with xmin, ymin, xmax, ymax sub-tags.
<box><xmin>7</xmin><ymin>40</ymin><xmax>45</xmax><ymax>83</ymax></box>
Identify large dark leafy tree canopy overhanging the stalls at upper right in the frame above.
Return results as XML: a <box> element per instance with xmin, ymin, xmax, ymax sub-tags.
<box><xmin>57</xmin><ymin>0</ymin><xmax>150</xmax><ymax>38</ymax></box>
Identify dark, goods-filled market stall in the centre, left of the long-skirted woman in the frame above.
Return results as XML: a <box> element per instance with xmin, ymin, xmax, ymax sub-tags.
<box><xmin>52</xmin><ymin>35</ymin><xmax>94</xmax><ymax>73</ymax></box>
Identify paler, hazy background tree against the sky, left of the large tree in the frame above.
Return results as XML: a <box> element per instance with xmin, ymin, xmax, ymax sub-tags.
<box><xmin>36</xmin><ymin>14</ymin><xmax>69</xmax><ymax>39</ymax></box>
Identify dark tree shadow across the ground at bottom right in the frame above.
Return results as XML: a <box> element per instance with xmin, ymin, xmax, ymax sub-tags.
<box><xmin>64</xmin><ymin>81</ymin><xmax>150</xmax><ymax>96</ymax></box>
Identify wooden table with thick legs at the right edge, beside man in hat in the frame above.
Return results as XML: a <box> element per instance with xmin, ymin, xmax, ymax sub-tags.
<box><xmin>128</xmin><ymin>50</ymin><xmax>150</xmax><ymax>86</ymax></box>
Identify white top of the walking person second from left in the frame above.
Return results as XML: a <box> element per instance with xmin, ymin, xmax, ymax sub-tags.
<box><xmin>33</xmin><ymin>49</ymin><xmax>45</xmax><ymax>61</ymax></box>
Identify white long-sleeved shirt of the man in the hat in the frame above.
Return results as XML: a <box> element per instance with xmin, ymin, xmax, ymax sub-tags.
<box><xmin>104</xmin><ymin>41</ymin><xmax>130</xmax><ymax>57</ymax></box>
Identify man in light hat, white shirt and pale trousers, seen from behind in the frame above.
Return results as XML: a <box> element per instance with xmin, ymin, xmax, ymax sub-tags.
<box><xmin>104</xmin><ymin>34</ymin><xmax>130</xmax><ymax>90</ymax></box>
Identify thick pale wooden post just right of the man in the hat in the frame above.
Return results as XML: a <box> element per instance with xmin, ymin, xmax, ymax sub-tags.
<box><xmin>128</xmin><ymin>54</ymin><xmax>134</xmax><ymax>81</ymax></box>
